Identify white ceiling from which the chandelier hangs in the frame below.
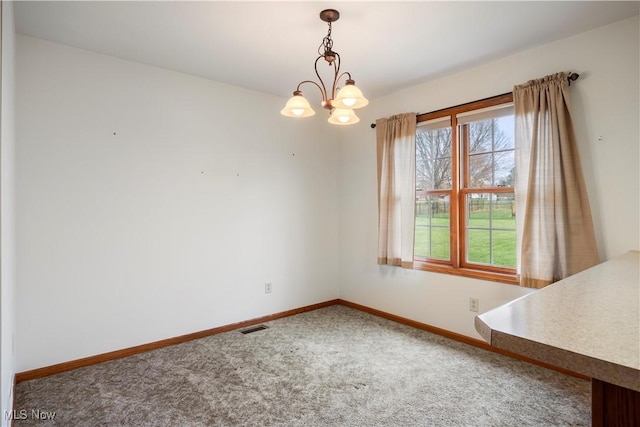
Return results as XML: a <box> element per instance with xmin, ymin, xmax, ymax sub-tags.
<box><xmin>14</xmin><ymin>1</ymin><xmax>640</xmax><ymax>103</ymax></box>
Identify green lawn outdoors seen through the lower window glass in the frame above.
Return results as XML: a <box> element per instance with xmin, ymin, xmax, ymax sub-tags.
<box><xmin>414</xmin><ymin>202</ymin><xmax>516</xmax><ymax>268</ymax></box>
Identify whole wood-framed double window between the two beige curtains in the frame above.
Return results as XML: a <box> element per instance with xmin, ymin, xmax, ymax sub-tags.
<box><xmin>414</xmin><ymin>93</ymin><xmax>516</xmax><ymax>283</ymax></box>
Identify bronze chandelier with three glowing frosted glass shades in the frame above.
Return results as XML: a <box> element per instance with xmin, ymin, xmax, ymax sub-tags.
<box><xmin>280</xmin><ymin>9</ymin><xmax>369</xmax><ymax>125</ymax></box>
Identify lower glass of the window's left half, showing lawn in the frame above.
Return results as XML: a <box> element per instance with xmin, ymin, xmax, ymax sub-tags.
<box><xmin>414</xmin><ymin>195</ymin><xmax>451</xmax><ymax>260</ymax></box>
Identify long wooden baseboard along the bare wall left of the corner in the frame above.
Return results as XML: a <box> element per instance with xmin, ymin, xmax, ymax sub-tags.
<box><xmin>14</xmin><ymin>299</ymin><xmax>338</xmax><ymax>382</ymax></box>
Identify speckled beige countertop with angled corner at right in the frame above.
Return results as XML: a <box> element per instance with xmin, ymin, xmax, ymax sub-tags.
<box><xmin>475</xmin><ymin>251</ymin><xmax>640</xmax><ymax>391</ymax></box>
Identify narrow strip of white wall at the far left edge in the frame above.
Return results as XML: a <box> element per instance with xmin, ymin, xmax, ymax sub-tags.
<box><xmin>0</xmin><ymin>2</ymin><xmax>16</xmax><ymax>426</ymax></box>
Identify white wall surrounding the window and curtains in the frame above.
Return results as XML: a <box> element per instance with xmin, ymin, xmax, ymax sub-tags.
<box><xmin>339</xmin><ymin>17</ymin><xmax>640</xmax><ymax>338</ymax></box>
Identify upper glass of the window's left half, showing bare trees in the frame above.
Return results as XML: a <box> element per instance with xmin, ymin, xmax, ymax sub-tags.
<box><xmin>416</xmin><ymin>126</ymin><xmax>452</xmax><ymax>190</ymax></box>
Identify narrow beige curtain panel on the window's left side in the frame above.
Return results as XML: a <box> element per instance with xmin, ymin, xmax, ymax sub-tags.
<box><xmin>376</xmin><ymin>113</ymin><xmax>416</xmax><ymax>268</ymax></box>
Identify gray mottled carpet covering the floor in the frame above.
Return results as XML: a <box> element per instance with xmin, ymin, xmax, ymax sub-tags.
<box><xmin>15</xmin><ymin>306</ymin><xmax>591</xmax><ymax>426</ymax></box>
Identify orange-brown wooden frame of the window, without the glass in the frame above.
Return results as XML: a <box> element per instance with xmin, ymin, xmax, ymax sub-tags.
<box><xmin>413</xmin><ymin>92</ymin><xmax>518</xmax><ymax>284</ymax></box>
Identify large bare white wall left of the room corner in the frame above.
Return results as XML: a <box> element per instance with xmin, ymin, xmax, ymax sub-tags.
<box><xmin>16</xmin><ymin>35</ymin><xmax>339</xmax><ymax>371</ymax></box>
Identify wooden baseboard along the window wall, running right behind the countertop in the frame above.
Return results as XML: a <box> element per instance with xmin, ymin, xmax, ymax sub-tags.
<box><xmin>337</xmin><ymin>299</ymin><xmax>591</xmax><ymax>381</ymax></box>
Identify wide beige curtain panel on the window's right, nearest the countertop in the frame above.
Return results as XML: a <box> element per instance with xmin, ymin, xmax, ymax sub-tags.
<box><xmin>513</xmin><ymin>73</ymin><xmax>599</xmax><ymax>288</ymax></box>
